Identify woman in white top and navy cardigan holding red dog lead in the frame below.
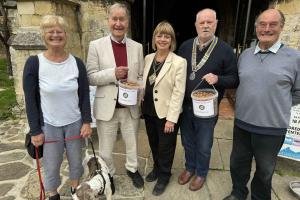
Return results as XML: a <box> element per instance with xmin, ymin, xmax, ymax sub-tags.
<box><xmin>23</xmin><ymin>15</ymin><xmax>92</xmax><ymax>200</ymax></box>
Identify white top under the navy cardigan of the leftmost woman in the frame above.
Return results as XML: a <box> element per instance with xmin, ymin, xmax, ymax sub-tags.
<box><xmin>38</xmin><ymin>53</ymin><xmax>81</xmax><ymax>127</ymax></box>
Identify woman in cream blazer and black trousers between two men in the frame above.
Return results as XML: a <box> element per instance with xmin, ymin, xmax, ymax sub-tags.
<box><xmin>142</xmin><ymin>21</ymin><xmax>187</xmax><ymax>196</ymax></box>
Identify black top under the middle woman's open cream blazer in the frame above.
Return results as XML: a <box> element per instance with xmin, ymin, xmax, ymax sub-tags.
<box><xmin>142</xmin><ymin>60</ymin><xmax>164</xmax><ymax>117</ymax></box>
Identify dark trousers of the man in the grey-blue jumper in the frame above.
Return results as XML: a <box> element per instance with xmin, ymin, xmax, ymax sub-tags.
<box><xmin>230</xmin><ymin>126</ymin><xmax>285</xmax><ymax>200</ymax></box>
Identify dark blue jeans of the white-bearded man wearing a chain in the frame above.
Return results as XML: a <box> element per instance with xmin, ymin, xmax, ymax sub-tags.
<box><xmin>180</xmin><ymin>106</ymin><xmax>218</xmax><ymax>177</ymax></box>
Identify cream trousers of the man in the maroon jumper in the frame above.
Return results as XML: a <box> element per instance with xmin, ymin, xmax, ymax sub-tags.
<box><xmin>96</xmin><ymin>108</ymin><xmax>139</xmax><ymax>175</ymax></box>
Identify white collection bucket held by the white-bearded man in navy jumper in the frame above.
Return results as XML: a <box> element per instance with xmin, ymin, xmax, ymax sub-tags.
<box><xmin>191</xmin><ymin>89</ymin><xmax>218</xmax><ymax>118</ymax></box>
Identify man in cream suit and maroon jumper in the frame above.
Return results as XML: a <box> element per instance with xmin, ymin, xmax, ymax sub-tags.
<box><xmin>87</xmin><ymin>3</ymin><xmax>144</xmax><ymax>191</ymax></box>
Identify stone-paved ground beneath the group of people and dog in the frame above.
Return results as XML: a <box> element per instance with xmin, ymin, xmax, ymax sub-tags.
<box><xmin>0</xmin><ymin>119</ymin><xmax>300</xmax><ymax>200</ymax></box>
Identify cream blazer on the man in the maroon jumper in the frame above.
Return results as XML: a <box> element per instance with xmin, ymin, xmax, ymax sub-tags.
<box><xmin>86</xmin><ymin>36</ymin><xmax>144</xmax><ymax>121</ymax></box>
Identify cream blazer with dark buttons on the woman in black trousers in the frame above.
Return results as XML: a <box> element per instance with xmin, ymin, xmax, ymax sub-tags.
<box><xmin>143</xmin><ymin>52</ymin><xmax>187</xmax><ymax>123</ymax></box>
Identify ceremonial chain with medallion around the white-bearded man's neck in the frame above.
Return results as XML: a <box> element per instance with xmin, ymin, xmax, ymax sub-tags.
<box><xmin>189</xmin><ymin>36</ymin><xmax>218</xmax><ymax>81</ymax></box>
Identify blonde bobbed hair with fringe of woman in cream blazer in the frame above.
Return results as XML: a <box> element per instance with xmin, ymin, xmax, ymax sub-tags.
<box><xmin>152</xmin><ymin>21</ymin><xmax>176</xmax><ymax>51</ymax></box>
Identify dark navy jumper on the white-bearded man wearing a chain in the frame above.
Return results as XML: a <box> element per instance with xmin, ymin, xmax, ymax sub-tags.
<box><xmin>178</xmin><ymin>38</ymin><xmax>239</xmax><ymax>106</ymax></box>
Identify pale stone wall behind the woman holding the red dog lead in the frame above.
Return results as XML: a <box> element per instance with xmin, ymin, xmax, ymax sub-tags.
<box><xmin>10</xmin><ymin>0</ymin><xmax>112</xmax><ymax>107</ymax></box>
